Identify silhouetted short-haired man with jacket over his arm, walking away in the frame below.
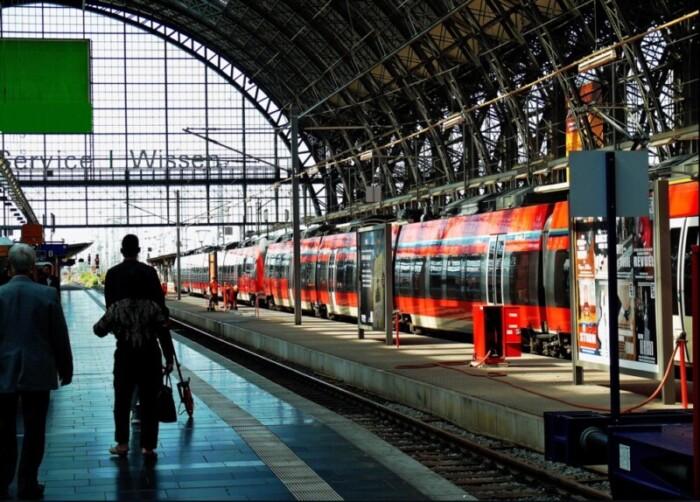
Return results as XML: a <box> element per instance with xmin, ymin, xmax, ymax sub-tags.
<box><xmin>99</xmin><ymin>234</ymin><xmax>174</xmax><ymax>458</ymax></box>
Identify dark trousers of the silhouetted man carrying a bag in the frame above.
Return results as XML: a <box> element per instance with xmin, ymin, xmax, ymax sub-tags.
<box><xmin>114</xmin><ymin>350</ymin><xmax>161</xmax><ymax>450</ymax></box>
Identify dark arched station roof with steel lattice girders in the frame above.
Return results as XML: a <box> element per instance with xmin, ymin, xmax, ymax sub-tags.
<box><xmin>0</xmin><ymin>0</ymin><xmax>698</xmax><ymax>220</ymax></box>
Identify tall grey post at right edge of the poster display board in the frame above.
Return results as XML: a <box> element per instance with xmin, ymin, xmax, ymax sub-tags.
<box><xmin>654</xmin><ymin>180</ymin><xmax>676</xmax><ymax>404</ymax></box>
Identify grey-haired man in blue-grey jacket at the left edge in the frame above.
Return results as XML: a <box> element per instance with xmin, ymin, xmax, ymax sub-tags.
<box><xmin>0</xmin><ymin>244</ymin><xmax>73</xmax><ymax>499</ymax></box>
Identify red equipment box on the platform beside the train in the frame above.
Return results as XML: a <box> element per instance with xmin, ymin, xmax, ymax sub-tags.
<box><xmin>472</xmin><ymin>305</ymin><xmax>522</xmax><ymax>364</ymax></box>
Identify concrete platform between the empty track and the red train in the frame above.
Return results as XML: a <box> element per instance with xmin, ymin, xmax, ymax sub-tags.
<box><xmin>168</xmin><ymin>296</ymin><xmax>688</xmax><ymax>452</ymax></box>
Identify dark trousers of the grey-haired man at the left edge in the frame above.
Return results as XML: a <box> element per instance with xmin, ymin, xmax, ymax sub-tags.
<box><xmin>0</xmin><ymin>391</ymin><xmax>49</xmax><ymax>492</ymax></box>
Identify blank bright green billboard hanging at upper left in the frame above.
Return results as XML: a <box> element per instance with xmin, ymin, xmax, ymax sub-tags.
<box><xmin>0</xmin><ymin>38</ymin><xmax>92</xmax><ymax>134</ymax></box>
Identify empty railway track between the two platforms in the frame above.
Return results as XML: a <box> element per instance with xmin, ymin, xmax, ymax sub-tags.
<box><xmin>172</xmin><ymin>319</ymin><xmax>611</xmax><ymax>500</ymax></box>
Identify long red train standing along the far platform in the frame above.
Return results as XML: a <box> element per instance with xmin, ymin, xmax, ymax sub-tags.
<box><xmin>163</xmin><ymin>182</ymin><xmax>700</xmax><ymax>356</ymax></box>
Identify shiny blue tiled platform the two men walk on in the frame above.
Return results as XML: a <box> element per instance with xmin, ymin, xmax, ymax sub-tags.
<box><xmin>5</xmin><ymin>291</ymin><xmax>471</xmax><ymax>500</ymax></box>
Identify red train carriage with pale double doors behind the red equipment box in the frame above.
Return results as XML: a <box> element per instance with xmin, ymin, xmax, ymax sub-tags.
<box><xmin>395</xmin><ymin>204</ymin><xmax>553</xmax><ymax>342</ymax></box>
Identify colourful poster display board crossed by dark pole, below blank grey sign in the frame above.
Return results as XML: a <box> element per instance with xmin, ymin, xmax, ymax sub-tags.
<box><xmin>575</xmin><ymin>217</ymin><xmax>658</xmax><ymax>372</ymax></box>
